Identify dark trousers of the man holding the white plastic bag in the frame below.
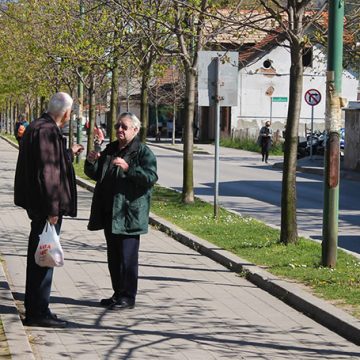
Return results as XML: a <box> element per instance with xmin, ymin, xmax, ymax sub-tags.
<box><xmin>24</xmin><ymin>214</ymin><xmax>61</xmax><ymax>318</ymax></box>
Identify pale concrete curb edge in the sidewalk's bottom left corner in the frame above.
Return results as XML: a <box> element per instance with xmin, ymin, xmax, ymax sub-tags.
<box><xmin>0</xmin><ymin>264</ymin><xmax>35</xmax><ymax>360</ymax></box>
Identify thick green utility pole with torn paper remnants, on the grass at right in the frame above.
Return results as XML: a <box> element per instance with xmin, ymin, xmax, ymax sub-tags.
<box><xmin>322</xmin><ymin>0</ymin><xmax>344</xmax><ymax>268</ymax></box>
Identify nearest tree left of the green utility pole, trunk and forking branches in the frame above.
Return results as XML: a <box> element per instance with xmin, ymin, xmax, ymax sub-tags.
<box><xmin>255</xmin><ymin>0</ymin><xmax>323</xmax><ymax>244</ymax></box>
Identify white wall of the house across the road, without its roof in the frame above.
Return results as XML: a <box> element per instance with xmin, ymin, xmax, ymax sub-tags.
<box><xmin>231</xmin><ymin>46</ymin><xmax>357</xmax><ymax>135</ymax></box>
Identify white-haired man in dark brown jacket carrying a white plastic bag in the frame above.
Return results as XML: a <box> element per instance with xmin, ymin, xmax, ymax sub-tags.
<box><xmin>14</xmin><ymin>92</ymin><xmax>83</xmax><ymax>327</ymax></box>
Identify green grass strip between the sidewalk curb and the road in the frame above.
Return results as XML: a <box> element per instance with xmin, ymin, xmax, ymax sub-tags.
<box><xmin>151</xmin><ymin>186</ymin><xmax>360</xmax><ymax>318</ymax></box>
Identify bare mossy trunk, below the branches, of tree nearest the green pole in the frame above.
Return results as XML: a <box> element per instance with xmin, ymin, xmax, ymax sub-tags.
<box><xmin>280</xmin><ymin>45</ymin><xmax>303</xmax><ymax>244</ymax></box>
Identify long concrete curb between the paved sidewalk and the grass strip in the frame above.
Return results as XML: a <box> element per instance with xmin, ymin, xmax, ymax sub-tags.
<box><xmin>76</xmin><ymin>178</ymin><xmax>360</xmax><ymax>345</ymax></box>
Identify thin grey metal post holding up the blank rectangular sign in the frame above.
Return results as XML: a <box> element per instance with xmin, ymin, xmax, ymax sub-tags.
<box><xmin>214</xmin><ymin>57</ymin><xmax>220</xmax><ymax>219</ymax></box>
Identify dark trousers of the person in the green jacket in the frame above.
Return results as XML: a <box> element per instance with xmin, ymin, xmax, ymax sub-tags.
<box><xmin>104</xmin><ymin>224</ymin><xmax>140</xmax><ymax>301</ymax></box>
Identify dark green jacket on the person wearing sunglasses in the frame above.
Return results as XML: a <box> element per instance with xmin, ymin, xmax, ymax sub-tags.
<box><xmin>84</xmin><ymin>137</ymin><xmax>158</xmax><ymax>235</ymax></box>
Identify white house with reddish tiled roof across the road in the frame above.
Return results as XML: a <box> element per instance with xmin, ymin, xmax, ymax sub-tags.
<box><xmin>200</xmin><ymin>35</ymin><xmax>358</xmax><ymax>139</ymax></box>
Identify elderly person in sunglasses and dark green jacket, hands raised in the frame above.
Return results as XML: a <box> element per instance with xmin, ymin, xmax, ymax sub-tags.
<box><xmin>84</xmin><ymin>112</ymin><xmax>158</xmax><ymax>309</ymax></box>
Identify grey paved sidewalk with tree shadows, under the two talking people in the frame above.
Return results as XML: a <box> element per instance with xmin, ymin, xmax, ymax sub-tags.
<box><xmin>0</xmin><ymin>139</ymin><xmax>360</xmax><ymax>360</ymax></box>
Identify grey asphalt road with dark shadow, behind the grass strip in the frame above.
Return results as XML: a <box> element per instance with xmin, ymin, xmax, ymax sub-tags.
<box><xmin>151</xmin><ymin>145</ymin><xmax>360</xmax><ymax>254</ymax></box>
